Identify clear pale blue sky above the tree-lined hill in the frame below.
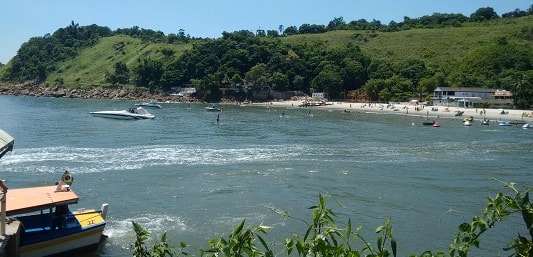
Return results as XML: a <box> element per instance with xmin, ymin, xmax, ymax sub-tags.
<box><xmin>0</xmin><ymin>0</ymin><xmax>533</xmax><ymax>64</ymax></box>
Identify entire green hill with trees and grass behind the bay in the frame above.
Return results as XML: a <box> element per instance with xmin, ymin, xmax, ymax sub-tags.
<box><xmin>0</xmin><ymin>14</ymin><xmax>533</xmax><ymax>107</ymax></box>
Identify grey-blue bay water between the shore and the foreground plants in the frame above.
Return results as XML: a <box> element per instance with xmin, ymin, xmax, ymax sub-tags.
<box><xmin>0</xmin><ymin>96</ymin><xmax>533</xmax><ymax>256</ymax></box>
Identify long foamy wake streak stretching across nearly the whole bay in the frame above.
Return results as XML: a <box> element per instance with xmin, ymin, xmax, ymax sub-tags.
<box><xmin>0</xmin><ymin>141</ymin><xmax>516</xmax><ymax>174</ymax></box>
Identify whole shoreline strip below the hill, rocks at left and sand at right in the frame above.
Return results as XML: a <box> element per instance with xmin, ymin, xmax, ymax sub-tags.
<box><xmin>0</xmin><ymin>81</ymin><xmax>533</xmax><ymax>123</ymax></box>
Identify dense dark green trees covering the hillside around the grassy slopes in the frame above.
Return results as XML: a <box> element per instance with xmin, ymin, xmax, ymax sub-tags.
<box><xmin>2</xmin><ymin>7</ymin><xmax>533</xmax><ymax>107</ymax></box>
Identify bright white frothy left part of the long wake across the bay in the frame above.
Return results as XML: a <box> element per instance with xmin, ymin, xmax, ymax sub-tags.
<box><xmin>0</xmin><ymin>145</ymin><xmax>302</xmax><ymax>173</ymax></box>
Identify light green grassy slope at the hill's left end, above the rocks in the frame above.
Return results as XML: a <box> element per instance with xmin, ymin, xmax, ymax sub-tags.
<box><xmin>46</xmin><ymin>35</ymin><xmax>192</xmax><ymax>87</ymax></box>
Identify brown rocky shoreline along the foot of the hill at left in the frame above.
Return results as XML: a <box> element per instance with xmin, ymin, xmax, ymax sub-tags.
<box><xmin>0</xmin><ymin>81</ymin><xmax>198</xmax><ymax>102</ymax></box>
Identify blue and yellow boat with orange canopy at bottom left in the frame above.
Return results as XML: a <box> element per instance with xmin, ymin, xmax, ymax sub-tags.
<box><xmin>1</xmin><ymin>172</ymin><xmax>107</xmax><ymax>257</ymax></box>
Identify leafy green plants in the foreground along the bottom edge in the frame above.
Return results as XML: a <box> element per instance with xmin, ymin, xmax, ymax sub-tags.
<box><xmin>132</xmin><ymin>181</ymin><xmax>533</xmax><ymax>257</ymax></box>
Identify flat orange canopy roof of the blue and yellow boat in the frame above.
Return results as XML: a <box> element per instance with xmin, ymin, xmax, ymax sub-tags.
<box><xmin>6</xmin><ymin>186</ymin><xmax>79</xmax><ymax>216</ymax></box>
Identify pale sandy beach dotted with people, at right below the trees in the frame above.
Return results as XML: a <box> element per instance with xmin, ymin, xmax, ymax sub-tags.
<box><xmin>254</xmin><ymin>100</ymin><xmax>533</xmax><ymax>123</ymax></box>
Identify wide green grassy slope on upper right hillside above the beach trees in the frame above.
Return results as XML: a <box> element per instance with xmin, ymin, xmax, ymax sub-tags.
<box><xmin>283</xmin><ymin>16</ymin><xmax>533</xmax><ymax>69</ymax></box>
